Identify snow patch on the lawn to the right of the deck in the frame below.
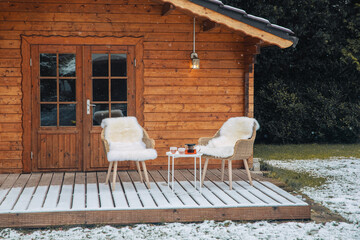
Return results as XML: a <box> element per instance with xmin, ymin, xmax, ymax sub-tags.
<box><xmin>269</xmin><ymin>158</ymin><xmax>360</xmax><ymax>224</ymax></box>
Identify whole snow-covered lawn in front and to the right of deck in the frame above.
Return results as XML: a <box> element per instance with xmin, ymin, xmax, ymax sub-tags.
<box><xmin>0</xmin><ymin>158</ymin><xmax>360</xmax><ymax>240</ymax></box>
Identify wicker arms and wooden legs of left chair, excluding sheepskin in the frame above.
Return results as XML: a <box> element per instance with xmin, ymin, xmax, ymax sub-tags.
<box><xmin>101</xmin><ymin>125</ymin><xmax>155</xmax><ymax>190</ymax></box>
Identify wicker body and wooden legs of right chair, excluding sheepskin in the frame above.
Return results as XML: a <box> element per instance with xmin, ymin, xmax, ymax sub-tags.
<box><xmin>198</xmin><ymin>124</ymin><xmax>256</xmax><ymax>190</ymax></box>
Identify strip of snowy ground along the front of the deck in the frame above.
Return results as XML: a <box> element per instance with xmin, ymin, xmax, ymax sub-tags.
<box><xmin>0</xmin><ymin>221</ymin><xmax>360</xmax><ymax>240</ymax></box>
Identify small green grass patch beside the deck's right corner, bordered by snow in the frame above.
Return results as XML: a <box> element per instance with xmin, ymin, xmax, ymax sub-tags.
<box><xmin>261</xmin><ymin>161</ymin><xmax>326</xmax><ymax>190</ymax></box>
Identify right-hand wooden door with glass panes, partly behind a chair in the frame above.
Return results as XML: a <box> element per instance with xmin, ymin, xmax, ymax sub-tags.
<box><xmin>84</xmin><ymin>46</ymin><xmax>135</xmax><ymax>170</ymax></box>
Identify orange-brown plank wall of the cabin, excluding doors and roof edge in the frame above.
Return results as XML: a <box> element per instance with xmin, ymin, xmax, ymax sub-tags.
<box><xmin>0</xmin><ymin>0</ymin><xmax>253</xmax><ymax>172</ymax></box>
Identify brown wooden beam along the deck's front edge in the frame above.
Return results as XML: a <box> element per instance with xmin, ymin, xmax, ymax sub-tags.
<box><xmin>0</xmin><ymin>206</ymin><xmax>310</xmax><ymax>228</ymax></box>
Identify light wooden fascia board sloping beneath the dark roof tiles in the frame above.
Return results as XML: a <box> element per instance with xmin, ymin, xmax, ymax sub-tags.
<box><xmin>158</xmin><ymin>0</ymin><xmax>294</xmax><ymax>48</ymax></box>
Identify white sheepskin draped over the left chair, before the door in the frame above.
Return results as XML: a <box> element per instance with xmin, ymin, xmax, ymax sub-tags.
<box><xmin>101</xmin><ymin>117</ymin><xmax>157</xmax><ymax>162</ymax></box>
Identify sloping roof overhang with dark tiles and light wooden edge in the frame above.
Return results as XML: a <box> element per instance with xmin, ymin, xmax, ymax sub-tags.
<box><xmin>155</xmin><ymin>0</ymin><xmax>298</xmax><ymax>48</ymax></box>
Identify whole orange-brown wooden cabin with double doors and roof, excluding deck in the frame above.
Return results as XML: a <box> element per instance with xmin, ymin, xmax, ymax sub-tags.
<box><xmin>0</xmin><ymin>0</ymin><xmax>297</xmax><ymax>173</ymax></box>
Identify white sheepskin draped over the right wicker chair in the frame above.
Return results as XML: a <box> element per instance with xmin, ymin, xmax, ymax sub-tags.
<box><xmin>199</xmin><ymin>117</ymin><xmax>260</xmax><ymax>158</ymax></box>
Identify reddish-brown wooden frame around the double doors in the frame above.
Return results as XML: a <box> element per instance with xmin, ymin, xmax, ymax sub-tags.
<box><xmin>21</xmin><ymin>35</ymin><xmax>144</xmax><ymax>172</ymax></box>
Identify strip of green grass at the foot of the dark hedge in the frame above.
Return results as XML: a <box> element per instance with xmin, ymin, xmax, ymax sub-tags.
<box><xmin>254</xmin><ymin>144</ymin><xmax>360</xmax><ymax>160</ymax></box>
